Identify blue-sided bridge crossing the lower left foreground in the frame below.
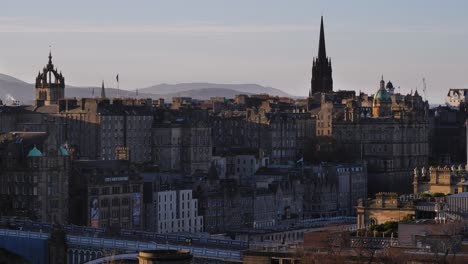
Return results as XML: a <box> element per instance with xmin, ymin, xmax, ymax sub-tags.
<box><xmin>0</xmin><ymin>229</ymin><xmax>242</xmax><ymax>264</ymax></box>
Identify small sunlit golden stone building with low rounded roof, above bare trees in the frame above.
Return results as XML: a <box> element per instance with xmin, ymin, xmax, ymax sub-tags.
<box><xmin>357</xmin><ymin>193</ymin><xmax>416</xmax><ymax>229</ymax></box>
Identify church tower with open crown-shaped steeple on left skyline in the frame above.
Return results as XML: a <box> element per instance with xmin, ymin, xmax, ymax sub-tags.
<box><xmin>36</xmin><ymin>52</ymin><xmax>65</xmax><ymax>106</ymax></box>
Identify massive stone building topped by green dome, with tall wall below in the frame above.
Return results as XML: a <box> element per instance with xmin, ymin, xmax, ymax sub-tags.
<box><xmin>331</xmin><ymin>77</ymin><xmax>429</xmax><ymax>194</ymax></box>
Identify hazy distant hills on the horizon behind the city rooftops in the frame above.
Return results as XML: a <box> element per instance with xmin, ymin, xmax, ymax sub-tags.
<box><xmin>0</xmin><ymin>73</ymin><xmax>292</xmax><ymax>104</ymax></box>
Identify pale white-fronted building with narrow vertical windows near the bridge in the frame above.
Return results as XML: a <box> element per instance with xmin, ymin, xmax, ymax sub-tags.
<box><xmin>153</xmin><ymin>190</ymin><xmax>203</xmax><ymax>233</ymax></box>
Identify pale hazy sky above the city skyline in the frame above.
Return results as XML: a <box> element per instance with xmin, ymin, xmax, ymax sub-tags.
<box><xmin>0</xmin><ymin>0</ymin><xmax>468</xmax><ymax>103</ymax></box>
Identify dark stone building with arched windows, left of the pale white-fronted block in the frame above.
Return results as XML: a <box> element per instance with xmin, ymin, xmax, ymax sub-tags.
<box><xmin>70</xmin><ymin>160</ymin><xmax>146</xmax><ymax>229</ymax></box>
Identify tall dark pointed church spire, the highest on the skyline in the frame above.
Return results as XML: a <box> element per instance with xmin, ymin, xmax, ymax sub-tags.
<box><xmin>309</xmin><ymin>16</ymin><xmax>333</xmax><ymax>96</ymax></box>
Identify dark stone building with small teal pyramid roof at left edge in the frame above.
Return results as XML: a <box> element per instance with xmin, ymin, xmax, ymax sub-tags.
<box><xmin>0</xmin><ymin>130</ymin><xmax>70</xmax><ymax>224</ymax></box>
